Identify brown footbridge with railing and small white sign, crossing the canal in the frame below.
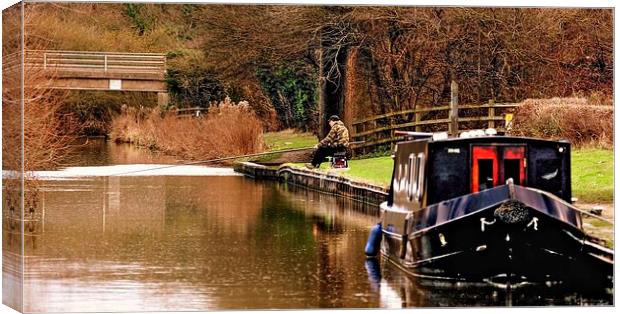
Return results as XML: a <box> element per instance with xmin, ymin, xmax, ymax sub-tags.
<box><xmin>24</xmin><ymin>50</ymin><xmax>168</xmax><ymax>105</ymax></box>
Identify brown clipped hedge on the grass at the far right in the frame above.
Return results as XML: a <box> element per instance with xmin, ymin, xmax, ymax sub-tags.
<box><xmin>511</xmin><ymin>98</ymin><xmax>614</xmax><ymax>149</ymax></box>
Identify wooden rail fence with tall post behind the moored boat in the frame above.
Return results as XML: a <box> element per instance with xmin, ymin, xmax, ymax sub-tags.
<box><xmin>351</xmin><ymin>82</ymin><xmax>518</xmax><ymax>153</ymax></box>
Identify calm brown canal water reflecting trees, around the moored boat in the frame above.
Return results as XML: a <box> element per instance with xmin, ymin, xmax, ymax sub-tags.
<box><xmin>3</xmin><ymin>141</ymin><xmax>612</xmax><ymax>312</ymax></box>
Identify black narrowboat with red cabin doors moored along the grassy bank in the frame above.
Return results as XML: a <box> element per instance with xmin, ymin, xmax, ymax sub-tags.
<box><xmin>366</xmin><ymin>132</ymin><xmax>613</xmax><ymax>287</ymax></box>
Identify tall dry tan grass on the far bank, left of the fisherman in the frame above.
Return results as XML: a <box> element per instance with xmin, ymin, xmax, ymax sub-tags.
<box><xmin>110</xmin><ymin>99</ymin><xmax>264</xmax><ymax>159</ymax></box>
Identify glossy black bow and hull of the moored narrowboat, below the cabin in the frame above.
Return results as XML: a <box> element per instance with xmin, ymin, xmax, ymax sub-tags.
<box><xmin>381</xmin><ymin>186</ymin><xmax>613</xmax><ymax>288</ymax></box>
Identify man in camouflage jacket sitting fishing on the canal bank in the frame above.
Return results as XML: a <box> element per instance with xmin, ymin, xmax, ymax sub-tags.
<box><xmin>306</xmin><ymin>115</ymin><xmax>349</xmax><ymax>169</ymax></box>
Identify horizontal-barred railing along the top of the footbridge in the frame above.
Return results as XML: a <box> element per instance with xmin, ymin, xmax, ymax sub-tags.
<box><xmin>24</xmin><ymin>50</ymin><xmax>166</xmax><ymax>74</ymax></box>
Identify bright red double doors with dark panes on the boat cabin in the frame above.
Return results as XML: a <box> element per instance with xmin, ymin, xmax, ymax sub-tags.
<box><xmin>471</xmin><ymin>145</ymin><xmax>525</xmax><ymax>192</ymax></box>
